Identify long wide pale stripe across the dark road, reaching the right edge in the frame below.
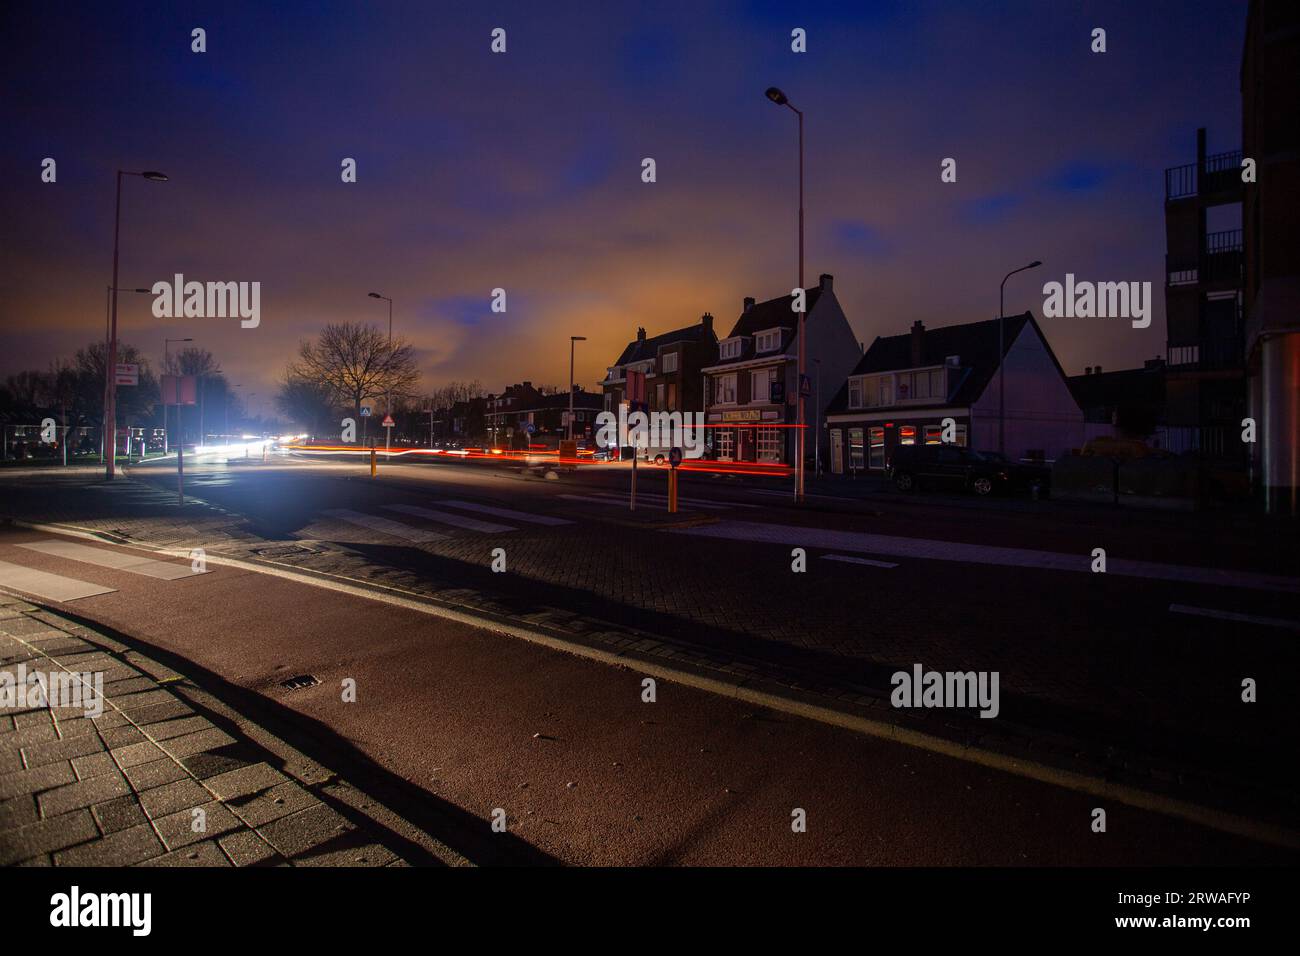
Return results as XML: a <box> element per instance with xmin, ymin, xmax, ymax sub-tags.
<box><xmin>667</xmin><ymin>520</ymin><xmax>1300</xmax><ymax>592</ymax></box>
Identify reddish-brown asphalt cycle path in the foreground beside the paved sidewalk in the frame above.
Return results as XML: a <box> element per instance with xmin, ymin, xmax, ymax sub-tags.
<box><xmin>0</xmin><ymin>529</ymin><xmax>1291</xmax><ymax>865</ymax></box>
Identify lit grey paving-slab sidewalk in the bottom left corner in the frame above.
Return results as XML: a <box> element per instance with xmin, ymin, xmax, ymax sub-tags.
<box><xmin>0</xmin><ymin>593</ymin><xmax>403</xmax><ymax>866</ymax></box>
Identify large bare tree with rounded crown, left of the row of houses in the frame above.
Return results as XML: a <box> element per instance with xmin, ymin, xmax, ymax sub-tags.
<box><xmin>285</xmin><ymin>323</ymin><xmax>420</xmax><ymax>415</ymax></box>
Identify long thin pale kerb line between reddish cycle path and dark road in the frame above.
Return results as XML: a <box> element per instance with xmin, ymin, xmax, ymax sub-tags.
<box><xmin>13</xmin><ymin>520</ymin><xmax>1300</xmax><ymax>849</ymax></box>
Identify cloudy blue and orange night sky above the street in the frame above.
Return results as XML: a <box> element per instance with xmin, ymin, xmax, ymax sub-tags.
<box><xmin>0</xmin><ymin>0</ymin><xmax>1245</xmax><ymax>410</ymax></box>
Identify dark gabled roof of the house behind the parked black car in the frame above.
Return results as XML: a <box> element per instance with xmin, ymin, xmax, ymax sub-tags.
<box><xmin>827</xmin><ymin>312</ymin><xmax>1065</xmax><ymax>415</ymax></box>
